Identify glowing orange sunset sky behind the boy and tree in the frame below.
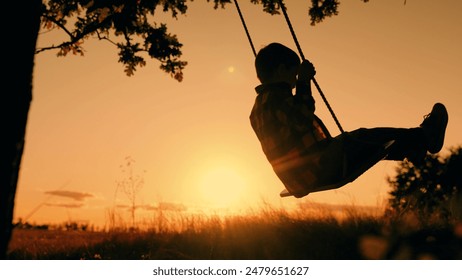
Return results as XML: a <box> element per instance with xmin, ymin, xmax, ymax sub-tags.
<box><xmin>15</xmin><ymin>0</ymin><xmax>462</xmax><ymax>228</ymax></box>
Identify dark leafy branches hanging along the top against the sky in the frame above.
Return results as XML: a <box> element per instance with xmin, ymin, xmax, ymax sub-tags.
<box><xmin>36</xmin><ymin>0</ymin><xmax>368</xmax><ymax>81</ymax></box>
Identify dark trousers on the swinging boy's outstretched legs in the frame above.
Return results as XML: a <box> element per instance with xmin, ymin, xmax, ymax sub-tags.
<box><xmin>315</xmin><ymin>127</ymin><xmax>426</xmax><ymax>188</ymax></box>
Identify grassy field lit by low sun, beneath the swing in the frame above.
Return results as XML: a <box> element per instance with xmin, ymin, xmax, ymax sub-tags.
<box><xmin>8</xmin><ymin>208</ymin><xmax>462</xmax><ymax>260</ymax></box>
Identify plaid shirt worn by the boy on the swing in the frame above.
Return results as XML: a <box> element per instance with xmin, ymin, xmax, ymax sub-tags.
<box><xmin>250</xmin><ymin>82</ymin><xmax>331</xmax><ymax>196</ymax></box>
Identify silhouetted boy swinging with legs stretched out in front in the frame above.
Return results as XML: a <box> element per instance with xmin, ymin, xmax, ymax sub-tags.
<box><xmin>250</xmin><ymin>43</ymin><xmax>448</xmax><ymax>198</ymax></box>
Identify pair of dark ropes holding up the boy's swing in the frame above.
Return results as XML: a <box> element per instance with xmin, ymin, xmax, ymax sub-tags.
<box><xmin>234</xmin><ymin>0</ymin><xmax>345</xmax><ymax>133</ymax></box>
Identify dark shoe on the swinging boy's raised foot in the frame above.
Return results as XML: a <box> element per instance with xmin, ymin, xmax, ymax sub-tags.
<box><xmin>420</xmin><ymin>103</ymin><xmax>448</xmax><ymax>154</ymax></box>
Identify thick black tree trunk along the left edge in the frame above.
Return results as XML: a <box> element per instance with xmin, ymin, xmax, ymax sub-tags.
<box><xmin>0</xmin><ymin>0</ymin><xmax>42</xmax><ymax>259</ymax></box>
